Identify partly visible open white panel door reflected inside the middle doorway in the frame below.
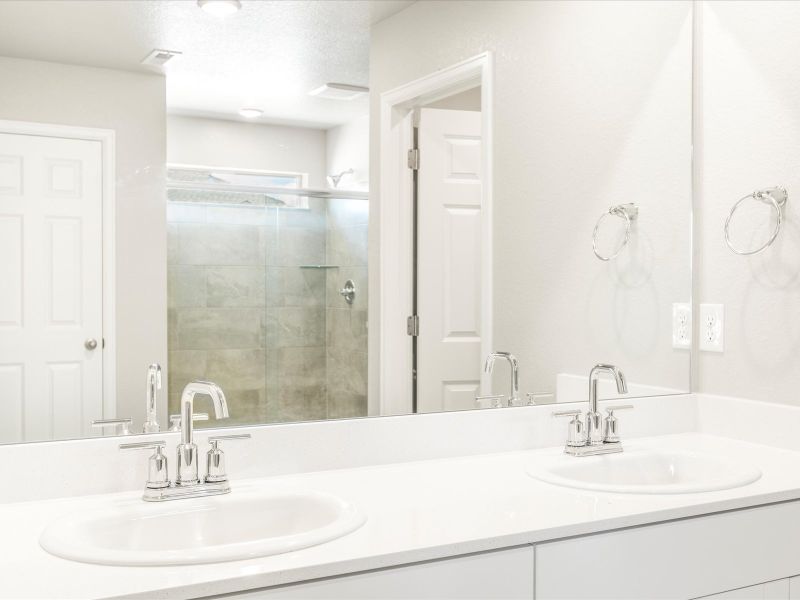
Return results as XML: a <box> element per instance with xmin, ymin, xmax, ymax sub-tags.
<box><xmin>417</xmin><ymin>108</ymin><xmax>489</xmax><ymax>412</ymax></box>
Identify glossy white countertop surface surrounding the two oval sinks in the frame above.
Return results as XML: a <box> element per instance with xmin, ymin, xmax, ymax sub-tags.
<box><xmin>0</xmin><ymin>433</ymin><xmax>800</xmax><ymax>599</ymax></box>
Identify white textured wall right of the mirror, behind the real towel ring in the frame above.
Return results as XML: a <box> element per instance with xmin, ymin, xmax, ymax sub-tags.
<box><xmin>697</xmin><ymin>2</ymin><xmax>800</xmax><ymax>405</ymax></box>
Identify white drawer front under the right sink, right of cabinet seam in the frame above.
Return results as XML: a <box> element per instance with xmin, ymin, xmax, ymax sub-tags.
<box><xmin>536</xmin><ymin>502</ymin><xmax>800</xmax><ymax>600</ymax></box>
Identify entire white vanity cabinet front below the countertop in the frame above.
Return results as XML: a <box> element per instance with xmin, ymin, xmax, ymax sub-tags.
<box><xmin>203</xmin><ymin>501</ymin><xmax>800</xmax><ymax>600</ymax></box>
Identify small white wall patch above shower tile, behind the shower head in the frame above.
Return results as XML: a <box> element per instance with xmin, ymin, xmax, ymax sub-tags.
<box><xmin>326</xmin><ymin>115</ymin><xmax>369</xmax><ymax>191</ymax></box>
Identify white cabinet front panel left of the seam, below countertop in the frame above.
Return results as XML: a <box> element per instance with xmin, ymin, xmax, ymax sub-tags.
<box><xmin>209</xmin><ymin>546</ymin><xmax>533</xmax><ymax>600</ymax></box>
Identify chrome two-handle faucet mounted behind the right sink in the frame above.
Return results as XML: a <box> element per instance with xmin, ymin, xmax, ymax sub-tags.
<box><xmin>553</xmin><ymin>363</ymin><xmax>633</xmax><ymax>456</ymax></box>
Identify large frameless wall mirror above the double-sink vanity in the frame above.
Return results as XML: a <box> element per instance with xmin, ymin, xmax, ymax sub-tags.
<box><xmin>0</xmin><ymin>0</ymin><xmax>692</xmax><ymax>443</ymax></box>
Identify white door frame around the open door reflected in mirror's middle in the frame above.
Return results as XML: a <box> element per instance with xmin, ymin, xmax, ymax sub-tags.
<box><xmin>376</xmin><ymin>52</ymin><xmax>494</xmax><ymax>415</ymax></box>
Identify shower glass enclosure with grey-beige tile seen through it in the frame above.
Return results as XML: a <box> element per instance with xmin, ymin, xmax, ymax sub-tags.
<box><xmin>167</xmin><ymin>169</ymin><xmax>368</xmax><ymax>427</ymax></box>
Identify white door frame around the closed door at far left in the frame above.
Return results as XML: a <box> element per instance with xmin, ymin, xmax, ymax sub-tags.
<box><xmin>0</xmin><ymin>120</ymin><xmax>117</xmax><ymax>418</ymax></box>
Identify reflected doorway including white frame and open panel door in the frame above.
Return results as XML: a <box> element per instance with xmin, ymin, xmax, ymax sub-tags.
<box><xmin>379</xmin><ymin>53</ymin><xmax>492</xmax><ymax>414</ymax></box>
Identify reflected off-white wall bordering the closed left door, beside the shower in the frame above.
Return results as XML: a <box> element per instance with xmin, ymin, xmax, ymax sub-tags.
<box><xmin>0</xmin><ymin>57</ymin><xmax>167</xmax><ymax>432</ymax></box>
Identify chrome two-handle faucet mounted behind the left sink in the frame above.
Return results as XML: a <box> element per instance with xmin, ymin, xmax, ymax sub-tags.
<box><xmin>120</xmin><ymin>381</ymin><xmax>250</xmax><ymax>502</ymax></box>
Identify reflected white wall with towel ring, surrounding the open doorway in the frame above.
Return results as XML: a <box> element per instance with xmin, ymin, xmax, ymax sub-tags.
<box><xmin>370</xmin><ymin>1</ymin><xmax>692</xmax><ymax>406</ymax></box>
